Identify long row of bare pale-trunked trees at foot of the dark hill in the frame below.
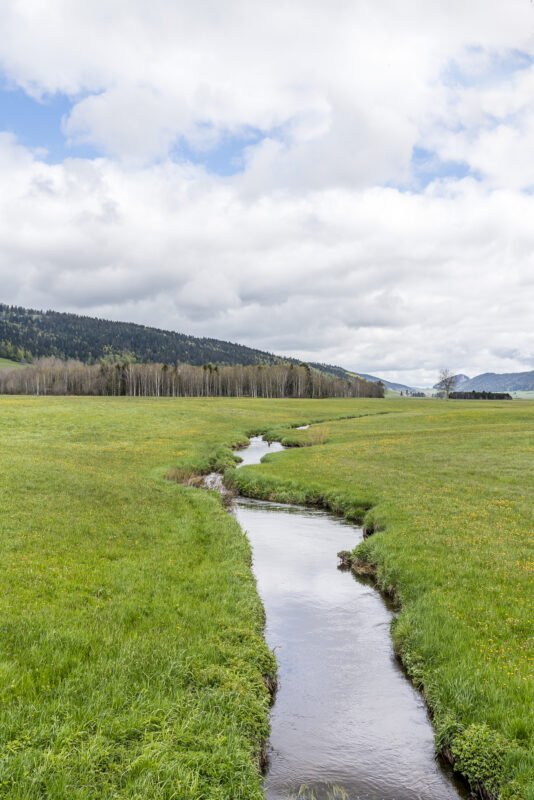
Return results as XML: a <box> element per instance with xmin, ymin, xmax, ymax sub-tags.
<box><xmin>0</xmin><ymin>358</ymin><xmax>384</xmax><ymax>398</ymax></box>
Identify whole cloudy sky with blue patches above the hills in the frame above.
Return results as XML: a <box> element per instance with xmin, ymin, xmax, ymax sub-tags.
<box><xmin>0</xmin><ymin>0</ymin><xmax>534</xmax><ymax>386</ymax></box>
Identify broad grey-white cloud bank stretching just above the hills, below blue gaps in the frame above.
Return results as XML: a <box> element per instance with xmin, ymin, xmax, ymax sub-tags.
<box><xmin>0</xmin><ymin>138</ymin><xmax>534</xmax><ymax>380</ymax></box>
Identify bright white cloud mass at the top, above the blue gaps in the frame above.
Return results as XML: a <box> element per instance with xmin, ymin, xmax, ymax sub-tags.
<box><xmin>0</xmin><ymin>0</ymin><xmax>532</xmax><ymax>167</ymax></box>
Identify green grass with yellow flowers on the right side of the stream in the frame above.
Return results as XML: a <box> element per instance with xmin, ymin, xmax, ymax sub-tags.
<box><xmin>228</xmin><ymin>399</ymin><xmax>534</xmax><ymax>800</ymax></box>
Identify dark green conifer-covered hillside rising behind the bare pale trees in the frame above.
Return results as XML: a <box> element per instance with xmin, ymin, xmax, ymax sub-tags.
<box><xmin>0</xmin><ymin>304</ymin><xmax>356</xmax><ymax>377</ymax></box>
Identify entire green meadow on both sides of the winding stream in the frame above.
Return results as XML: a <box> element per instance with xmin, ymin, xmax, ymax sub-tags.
<box><xmin>0</xmin><ymin>397</ymin><xmax>534</xmax><ymax>800</ymax></box>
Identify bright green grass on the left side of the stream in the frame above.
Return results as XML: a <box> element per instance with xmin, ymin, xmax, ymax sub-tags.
<box><xmin>0</xmin><ymin>397</ymin><xmax>364</xmax><ymax>800</ymax></box>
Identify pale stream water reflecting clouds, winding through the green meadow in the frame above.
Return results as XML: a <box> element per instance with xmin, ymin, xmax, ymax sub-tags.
<box><xmin>232</xmin><ymin>437</ymin><xmax>467</xmax><ymax>800</ymax></box>
